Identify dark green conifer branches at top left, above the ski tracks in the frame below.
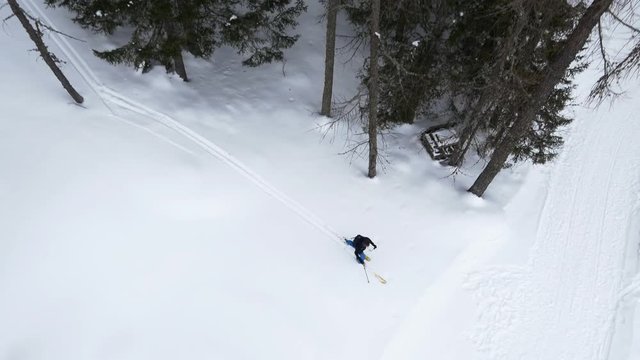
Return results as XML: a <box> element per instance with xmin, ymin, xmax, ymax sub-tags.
<box><xmin>46</xmin><ymin>0</ymin><xmax>306</xmax><ymax>72</ymax></box>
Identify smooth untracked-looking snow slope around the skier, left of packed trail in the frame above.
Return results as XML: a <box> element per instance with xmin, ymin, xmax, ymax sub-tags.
<box><xmin>0</xmin><ymin>2</ymin><xmax>500</xmax><ymax>359</ymax></box>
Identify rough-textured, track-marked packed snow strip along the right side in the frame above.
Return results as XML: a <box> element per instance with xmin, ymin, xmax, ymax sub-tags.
<box><xmin>465</xmin><ymin>112</ymin><xmax>640</xmax><ymax>360</ymax></box>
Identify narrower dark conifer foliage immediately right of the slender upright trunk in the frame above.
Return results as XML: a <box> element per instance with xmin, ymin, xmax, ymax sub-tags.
<box><xmin>346</xmin><ymin>0</ymin><xmax>447</xmax><ymax>126</ymax></box>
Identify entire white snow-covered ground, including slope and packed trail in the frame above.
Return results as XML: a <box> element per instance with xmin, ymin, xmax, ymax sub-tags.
<box><xmin>0</xmin><ymin>1</ymin><xmax>640</xmax><ymax>360</ymax></box>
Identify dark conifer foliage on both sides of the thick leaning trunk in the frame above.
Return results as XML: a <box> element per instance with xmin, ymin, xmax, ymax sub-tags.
<box><xmin>447</xmin><ymin>0</ymin><xmax>584</xmax><ymax>163</ymax></box>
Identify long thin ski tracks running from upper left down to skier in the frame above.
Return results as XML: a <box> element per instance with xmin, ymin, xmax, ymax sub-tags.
<box><xmin>24</xmin><ymin>0</ymin><xmax>373</xmax><ymax>270</ymax></box>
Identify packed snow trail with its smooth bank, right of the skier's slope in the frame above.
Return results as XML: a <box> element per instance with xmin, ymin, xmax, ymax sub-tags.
<box><xmin>382</xmin><ymin>83</ymin><xmax>640</xmax><ymax>360</ymax></box>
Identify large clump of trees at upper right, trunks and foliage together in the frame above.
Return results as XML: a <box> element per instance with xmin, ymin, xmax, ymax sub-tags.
<box><xmin>323</xmin><ymin>0</ymin><xmax>640</xmax><ymax>196</ymax></box>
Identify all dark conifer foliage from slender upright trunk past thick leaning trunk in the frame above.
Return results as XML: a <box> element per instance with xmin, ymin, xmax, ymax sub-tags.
<box><xmin>345</xmin><ymin>0</ymin><xmax>584</xmax><ymax>163</ymax></box>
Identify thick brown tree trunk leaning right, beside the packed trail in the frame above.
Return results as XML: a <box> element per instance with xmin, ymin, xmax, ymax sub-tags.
<box><xmin>469</xmin><ymin>0</ymin><xmax>613</xmax><ymax>196</ymax></box>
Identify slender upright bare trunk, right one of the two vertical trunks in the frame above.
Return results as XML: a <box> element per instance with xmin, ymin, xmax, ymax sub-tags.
<box><xmin>368</xmin><ymin>0</ymin><xmax>380</xmax><ymax>178</ymax></box>
